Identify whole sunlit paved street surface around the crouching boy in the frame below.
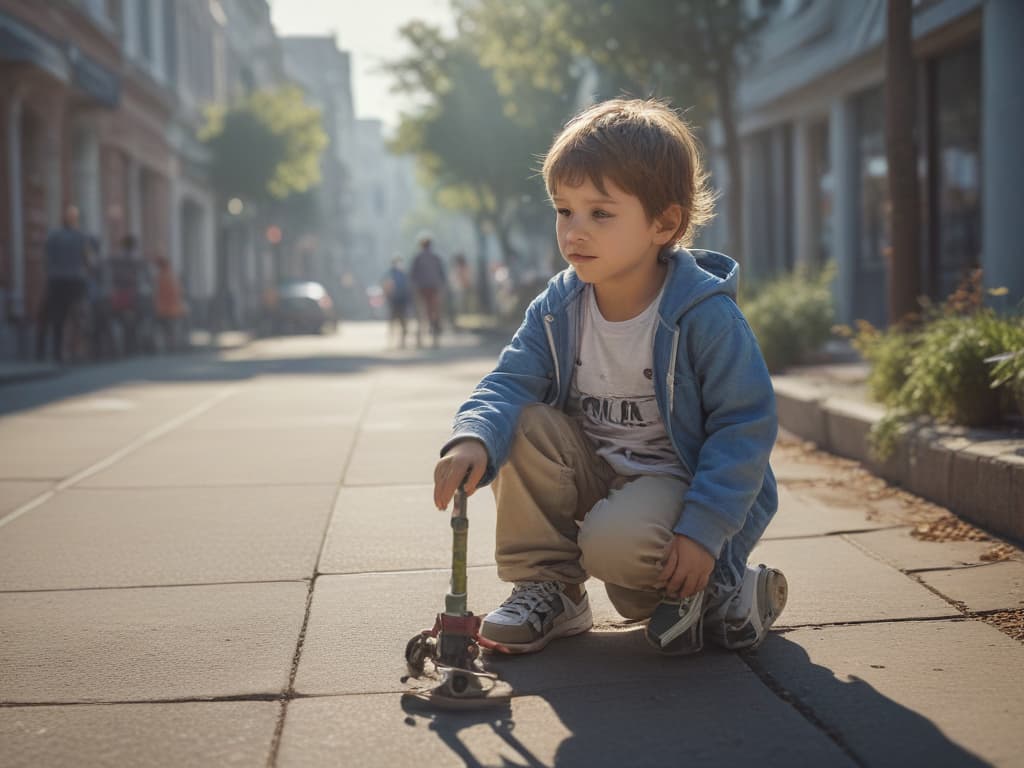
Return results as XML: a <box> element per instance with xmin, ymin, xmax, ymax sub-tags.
<box><xmin>0</xmin><ymin>323</ymin><xmax>1024</xmax><ymax>768</ymax></box>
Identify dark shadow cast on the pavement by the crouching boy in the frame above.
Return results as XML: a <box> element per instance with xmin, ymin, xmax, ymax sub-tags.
<box><xmin>402</xmin><ymin>630</ymin><xmax>989</xmax><ymax>768</ymax></box>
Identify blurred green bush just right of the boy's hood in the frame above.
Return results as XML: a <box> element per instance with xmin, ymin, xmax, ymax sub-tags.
<box><xmin>743</xmin><ymin>267</ymin><xmax>835</xmax><ymax>372</ymax></box>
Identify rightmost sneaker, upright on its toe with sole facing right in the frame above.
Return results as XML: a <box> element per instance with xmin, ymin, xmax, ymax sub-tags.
<box><xmin>708</xmin><ymin>565</ymin><xmax>790</xmax><ymax>650</ymax></box>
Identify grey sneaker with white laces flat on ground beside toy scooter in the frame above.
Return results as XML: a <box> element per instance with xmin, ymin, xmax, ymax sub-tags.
<box><xmin>480</xmin><ymin>582</ymin><xmax>594</xmax><ymax>653</ymax></box>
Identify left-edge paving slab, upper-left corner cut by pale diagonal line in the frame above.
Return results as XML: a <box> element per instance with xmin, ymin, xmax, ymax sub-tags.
<box><xmin>0</xmin><ymin>485</ymin><xmax>335</xmax><ymax>591</ymax></box>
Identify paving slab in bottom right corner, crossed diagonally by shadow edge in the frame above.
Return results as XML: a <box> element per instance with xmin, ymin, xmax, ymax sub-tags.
<box><xmin>755</xmin><ymin>622</ymin><xmax>1024</xmax><ymax>768</ymax></box>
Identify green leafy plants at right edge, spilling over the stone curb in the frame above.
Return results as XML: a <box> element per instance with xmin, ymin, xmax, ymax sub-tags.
<box><xmin>853</xmin><ymin>272</ymin><xmax>1024</xmax><ymax>459</ymax></box>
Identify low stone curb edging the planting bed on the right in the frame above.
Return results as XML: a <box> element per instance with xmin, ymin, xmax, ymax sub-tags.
<box><xmin>773</xmin><ymin>380</ymin><xmax>1024</xmax><ymax>541</ymax></box>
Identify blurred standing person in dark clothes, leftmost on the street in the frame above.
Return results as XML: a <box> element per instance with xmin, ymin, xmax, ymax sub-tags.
<box><xmin>36</xmin><ymin>205</ymin><xmax>90</xmax><ymax>362</ymax></box>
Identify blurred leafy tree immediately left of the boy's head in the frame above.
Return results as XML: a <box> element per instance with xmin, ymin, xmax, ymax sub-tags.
<box><xmin>387</xmin><ymin>18</ymin><xmax>581</xmax><ymax>307</ymax></box>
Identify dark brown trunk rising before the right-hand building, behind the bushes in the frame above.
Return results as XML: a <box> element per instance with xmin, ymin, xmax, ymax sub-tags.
<box><xmin>886</xmin><ymin>0</ymin><xmax>921</xmax><ymax>324</ymax></box>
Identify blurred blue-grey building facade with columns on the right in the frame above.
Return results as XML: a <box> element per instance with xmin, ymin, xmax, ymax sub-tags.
<box><xmin>720</xmin><ymin>0</ymin><xmax>1024</xmax><ymax>325</ymax></box>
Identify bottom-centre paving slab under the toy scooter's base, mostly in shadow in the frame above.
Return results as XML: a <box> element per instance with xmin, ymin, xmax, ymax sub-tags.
<box><xmin>278</xmin><ymin>684</ymin><xmax>853</xmax><ymax>768</ymax></box>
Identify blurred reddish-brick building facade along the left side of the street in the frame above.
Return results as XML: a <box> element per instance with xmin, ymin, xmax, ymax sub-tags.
<box><xmin>0</xmin><ymin>0</ymin><xmax>231</xmax><ymax>356</ymax></box>
